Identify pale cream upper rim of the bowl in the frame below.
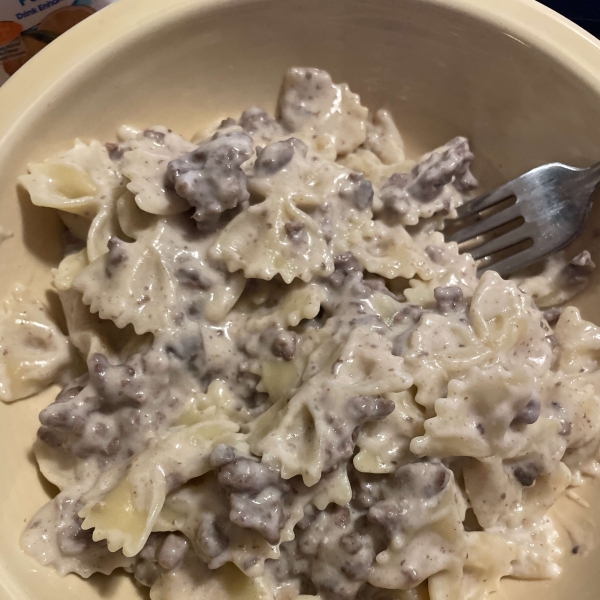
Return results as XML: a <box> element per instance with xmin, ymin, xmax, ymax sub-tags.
<box><xmin>0</xmin><ymin>0</ymin><xmax>600</xmax><ymax>152</ymax></box>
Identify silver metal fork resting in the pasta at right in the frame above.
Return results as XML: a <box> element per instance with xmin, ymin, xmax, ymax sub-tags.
<box><xmin>446</xmin><ymin>163</ymin><xmax>600</xmax><ymax>277</ymax></box>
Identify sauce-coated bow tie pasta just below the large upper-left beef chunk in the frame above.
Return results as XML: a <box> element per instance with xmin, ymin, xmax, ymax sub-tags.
<box><xmin>74</xmin><ymin>217</ymin><xmax>245</xmax><ymax>335</ymax></box>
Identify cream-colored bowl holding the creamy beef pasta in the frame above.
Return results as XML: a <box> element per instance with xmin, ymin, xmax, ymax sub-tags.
<box><xmin>0</xmin><ymin>0</ymin><xmax>600</xmax><ymax>600</ymax></box>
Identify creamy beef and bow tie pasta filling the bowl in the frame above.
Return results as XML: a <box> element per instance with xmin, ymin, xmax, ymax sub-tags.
<box><xmin>0</xmin><ymin>68</ymin><xmax>600</xmax><ymax>600</ymax></box>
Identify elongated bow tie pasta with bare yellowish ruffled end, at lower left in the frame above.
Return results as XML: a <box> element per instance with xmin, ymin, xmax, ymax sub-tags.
<box><xmin>79</xmin><ymin>420</ymin><xmax>243</xmax><ymax>556</ymax></box>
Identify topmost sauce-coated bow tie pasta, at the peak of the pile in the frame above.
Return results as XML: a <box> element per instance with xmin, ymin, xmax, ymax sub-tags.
<box><xmin>277</xmin><ymin>68</ymin><xmax>369</xmax><ymax>160</ymax></box>
